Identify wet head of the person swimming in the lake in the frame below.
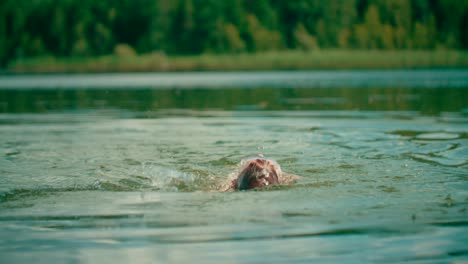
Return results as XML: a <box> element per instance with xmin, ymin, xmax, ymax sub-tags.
<box><xmin>236</xmin><ymin>156</ymin><xmax>281</xmax><ymax>190</ymax></box>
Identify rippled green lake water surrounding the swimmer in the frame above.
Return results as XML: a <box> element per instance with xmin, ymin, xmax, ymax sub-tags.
<box><xmin>0</xmin><ymin>70</ymin><xmax>468</xmax><ymax>263</ymax></box>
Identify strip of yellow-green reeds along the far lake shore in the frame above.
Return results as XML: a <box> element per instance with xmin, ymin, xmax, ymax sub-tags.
<box><xmin>6</xmin><ymin>50</ymin><xmax>468</xmax><ymax>73</ymax></box>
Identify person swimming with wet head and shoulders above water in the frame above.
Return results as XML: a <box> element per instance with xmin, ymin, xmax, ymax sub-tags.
<box><xmin>226</xmin><ymin>154</ymin><xmax>301</xmax><ymax>191</ymax></box>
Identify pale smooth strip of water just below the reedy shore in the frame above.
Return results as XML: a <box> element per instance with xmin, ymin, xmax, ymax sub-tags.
<box><xmin>0</xmin><ymin>69</ymin><xmax>468</xmax><ymax>89</ymax></box>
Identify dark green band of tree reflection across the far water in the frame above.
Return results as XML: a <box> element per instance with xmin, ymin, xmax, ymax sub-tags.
<box><xmin>0</xmin><ymin>86</ymin><xmax>468</xmax><ymax>115</ymax></box>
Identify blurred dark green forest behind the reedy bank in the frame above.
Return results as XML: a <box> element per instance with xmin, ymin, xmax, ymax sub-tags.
<box><xmin>0</xmin><ymin>0</ymin><xmax>468</xmax><ymax>65</ymax></box>
